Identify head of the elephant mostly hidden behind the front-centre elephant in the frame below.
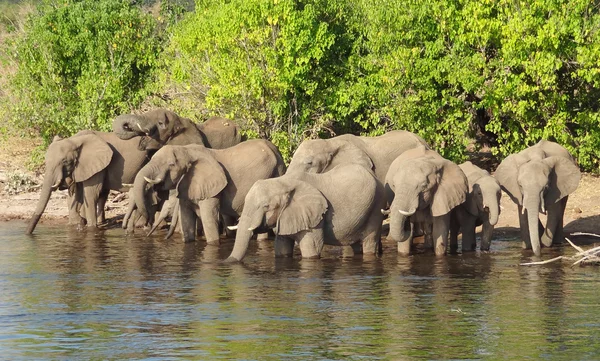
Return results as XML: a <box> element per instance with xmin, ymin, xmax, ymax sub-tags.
<box><xmin>288</xmin><ymin>136</ymin><xmax>373</xmax><ymax>173</ymax></box>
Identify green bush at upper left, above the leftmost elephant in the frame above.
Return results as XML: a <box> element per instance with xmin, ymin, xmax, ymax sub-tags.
<box><xmin>6</xmin><ymin>0</ymin><xmax>161</xmax><ymax>141</ymax></box>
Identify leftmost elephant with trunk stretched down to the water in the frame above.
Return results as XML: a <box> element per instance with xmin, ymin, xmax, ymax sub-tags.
<box><xmin>26</xmin><ymin>131</ymin><xmax>148</xmax><ymax>234</ymax></box>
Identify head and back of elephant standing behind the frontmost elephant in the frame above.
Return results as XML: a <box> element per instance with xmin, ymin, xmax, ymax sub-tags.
<box><xmin>288</xmin><ymin>130</ymin><xmax>428</xmax><ymax>183</ymax></box>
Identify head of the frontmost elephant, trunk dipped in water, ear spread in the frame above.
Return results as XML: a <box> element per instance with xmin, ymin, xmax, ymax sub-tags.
<box><xmin>228</xmin><ymin>176</ymin><xmax>328</xmax><ymax>262</ymax></box>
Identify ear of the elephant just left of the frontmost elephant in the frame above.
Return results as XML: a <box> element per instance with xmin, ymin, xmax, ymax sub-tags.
<box><xmin>177</xmin><ymin>155</ymin><xmax>227</xmax><ymax>202</ymax></box>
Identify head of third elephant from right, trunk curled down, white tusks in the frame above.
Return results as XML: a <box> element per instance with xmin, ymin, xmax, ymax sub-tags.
<box><xmin>386</xmin><ymin>148</ymin><xmax>468</xmax><ymax>242</ymax></box>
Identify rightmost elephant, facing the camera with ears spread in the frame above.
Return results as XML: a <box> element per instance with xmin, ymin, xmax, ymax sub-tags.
<box><xmin>494</xmin><ymin>140</ymin><xmax>581</xmax><ymax>256</ymax></box>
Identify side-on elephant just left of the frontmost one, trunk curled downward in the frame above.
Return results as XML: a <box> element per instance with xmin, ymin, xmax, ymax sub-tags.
<box><xmin>134</xmin><ymin>139</ymin><xmax>285</xmax><ymax>244</ymax></box>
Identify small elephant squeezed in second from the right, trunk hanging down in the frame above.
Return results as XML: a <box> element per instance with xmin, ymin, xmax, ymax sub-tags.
<box><xmin>450</xmin><ymin>162</ymin><xmax>502</xmax><ymax>252</ymax></box>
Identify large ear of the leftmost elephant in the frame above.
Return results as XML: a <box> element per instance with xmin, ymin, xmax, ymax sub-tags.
<box><xmin>69</xmin><ymin>134</ymin><xmax>113</xmax><ymax>182</ymax></box>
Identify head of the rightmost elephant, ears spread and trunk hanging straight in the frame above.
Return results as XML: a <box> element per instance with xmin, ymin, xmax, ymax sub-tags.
<box><xmin>494</xmin><ymin>141</ymin><xmax>581</xmax><ymax>256</ymax></box>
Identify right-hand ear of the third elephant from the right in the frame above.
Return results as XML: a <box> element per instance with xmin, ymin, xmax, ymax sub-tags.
<box><xmin>431</xmin><ymin>159</ymin><xmax>469</xmax><ymax>217</ymax></box>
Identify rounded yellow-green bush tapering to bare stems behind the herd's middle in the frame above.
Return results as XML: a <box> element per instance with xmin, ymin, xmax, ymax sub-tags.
<box><xmin>165</xmin><ymin>0</ymin><xmax>352</xmax><ymax>159</ymax></box>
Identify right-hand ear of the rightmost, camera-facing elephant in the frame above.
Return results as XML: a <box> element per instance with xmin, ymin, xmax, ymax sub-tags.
<box><xmin>543</xmin><ymin>156</ymin><xmax>581</xmax><ymax>204</ymax></box>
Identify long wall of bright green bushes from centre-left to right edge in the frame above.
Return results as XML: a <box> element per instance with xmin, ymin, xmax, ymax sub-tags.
<box><xmin>164</xmin><ymin>0</ymin><xmax>600</xmax><ymax>171</ymax></box>
